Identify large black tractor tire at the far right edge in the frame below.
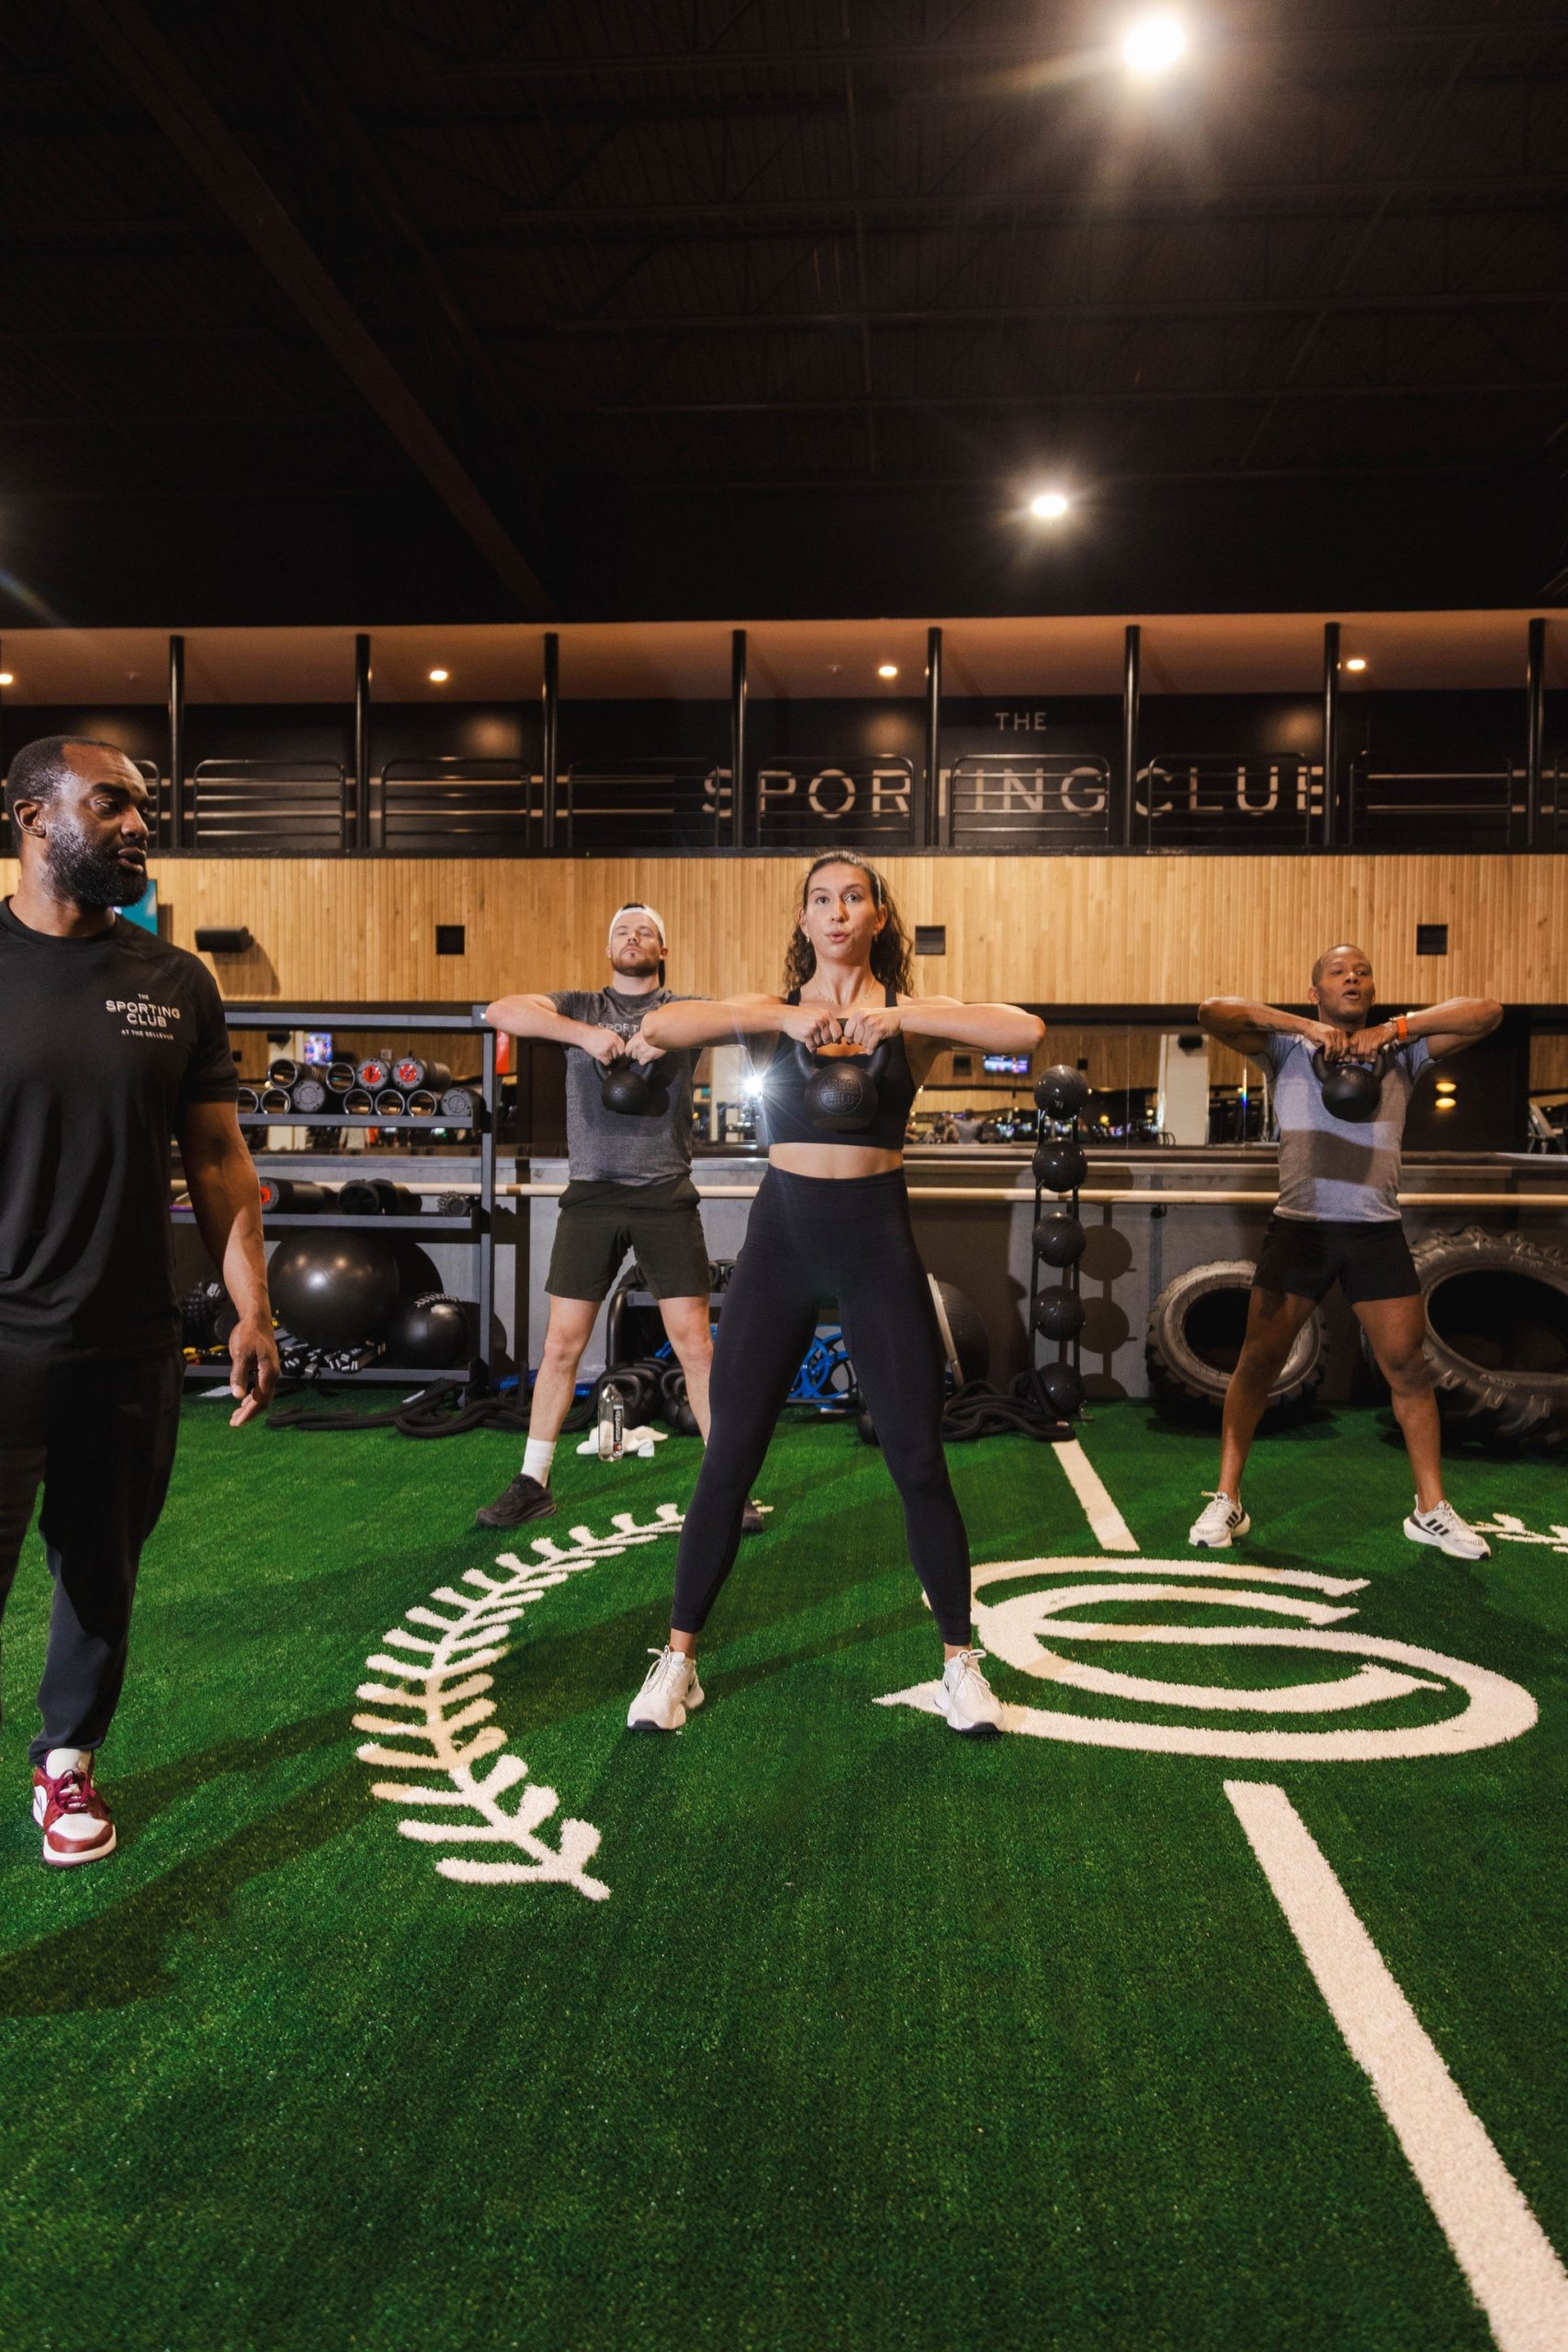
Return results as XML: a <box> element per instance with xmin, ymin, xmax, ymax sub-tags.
<box><xmin>1368</xmin><ymin>1226</ymin><xmax>1568</xmax><ymax>1444</ymax></box>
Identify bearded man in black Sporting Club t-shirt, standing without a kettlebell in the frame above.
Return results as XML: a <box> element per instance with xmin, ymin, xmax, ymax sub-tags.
<box><xmin>0</xmin><ymin>736</ymin><xmax>277</xmax><ymax>1868</ymax></box>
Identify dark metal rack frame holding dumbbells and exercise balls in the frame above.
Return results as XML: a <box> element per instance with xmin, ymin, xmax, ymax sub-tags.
<box><xmin>186</xmin><ymin>1004</ymin><xmax>501</xmax><ymax>1395</ymax></box>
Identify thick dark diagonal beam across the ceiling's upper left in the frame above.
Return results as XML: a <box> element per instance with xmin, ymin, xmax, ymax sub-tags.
<box><xmin>66</xmin><ymin>0</ymin><xmax>552</xmax><ymax>618</ymax></box>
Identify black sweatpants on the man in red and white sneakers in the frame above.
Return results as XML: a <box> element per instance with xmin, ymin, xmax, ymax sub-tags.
<box><xmin>0</xmin><ymin>1355</ymin><xmax>184</xmax><ymax>1764</ymax></box>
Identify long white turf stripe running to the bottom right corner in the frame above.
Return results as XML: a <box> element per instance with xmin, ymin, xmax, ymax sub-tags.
<box><xmin>1224</xmin><ymin>1781</ymin><xmax>1568</xmax><ymax>2352</ymax></box>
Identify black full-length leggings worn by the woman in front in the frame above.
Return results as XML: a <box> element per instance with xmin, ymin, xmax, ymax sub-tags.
<box><xmin>670</xmin><ymin>1167</ymin><xmax>971</xmax><ymax>1644</ymax></box>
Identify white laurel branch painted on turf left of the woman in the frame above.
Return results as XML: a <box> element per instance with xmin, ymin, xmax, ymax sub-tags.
<box><xmin>353</xmin><ymin>1503</ymin><xmax>682</xmax><ymax>1903</ymax></box>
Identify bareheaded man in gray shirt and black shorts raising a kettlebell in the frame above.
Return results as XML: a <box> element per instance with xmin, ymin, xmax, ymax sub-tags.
<box><xmin>1187</xmin><ymin>945</ymin><xmax>1502</xmax><ymax>1559</ymax></box>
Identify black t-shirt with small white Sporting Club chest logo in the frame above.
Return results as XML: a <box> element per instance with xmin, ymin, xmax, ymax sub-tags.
<box><xmin>0</xmin><ymin>899</ymin><xmax>235</xmax><ymax>1360</ymax></box>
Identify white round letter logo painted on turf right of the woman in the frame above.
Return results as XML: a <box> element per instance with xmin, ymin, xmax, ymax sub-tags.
<box><xmin>879</xmin><ymin>1559</ymin><xmax>1538</xmax><ymax>1764</ymax></box>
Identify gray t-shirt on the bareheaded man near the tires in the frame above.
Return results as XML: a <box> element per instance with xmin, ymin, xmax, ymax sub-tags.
<box><xmin>1253</xmin><ymin>1030</ymin><xmax>1432</xmax><ymax>1226</ymax></box>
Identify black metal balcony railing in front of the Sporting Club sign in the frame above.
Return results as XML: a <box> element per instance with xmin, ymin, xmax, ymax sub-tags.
<box><xmin>0</xmin><ymin>751</ymin><xmax>1568</xmax><ymax>858</ymax></box>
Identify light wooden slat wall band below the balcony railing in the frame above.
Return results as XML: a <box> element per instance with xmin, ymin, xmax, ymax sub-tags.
<box><xmin>0</xmin><ymin>856</ymin><xmax>1568</xmax><ymax>1004</ymax></box>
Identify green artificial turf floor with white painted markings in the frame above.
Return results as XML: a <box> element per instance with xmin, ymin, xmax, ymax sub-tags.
<box><xmin>0</xmin><ymin>1402</ymin><xmax>1568</xmax><ymax>2352</ymax></box>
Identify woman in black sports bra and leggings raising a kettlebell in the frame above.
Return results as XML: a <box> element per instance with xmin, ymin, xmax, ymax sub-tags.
<box><xmin>627</xmin><ymin>854</ymin><xmax>1046</xmax><ymax>1731</ymax></box>
